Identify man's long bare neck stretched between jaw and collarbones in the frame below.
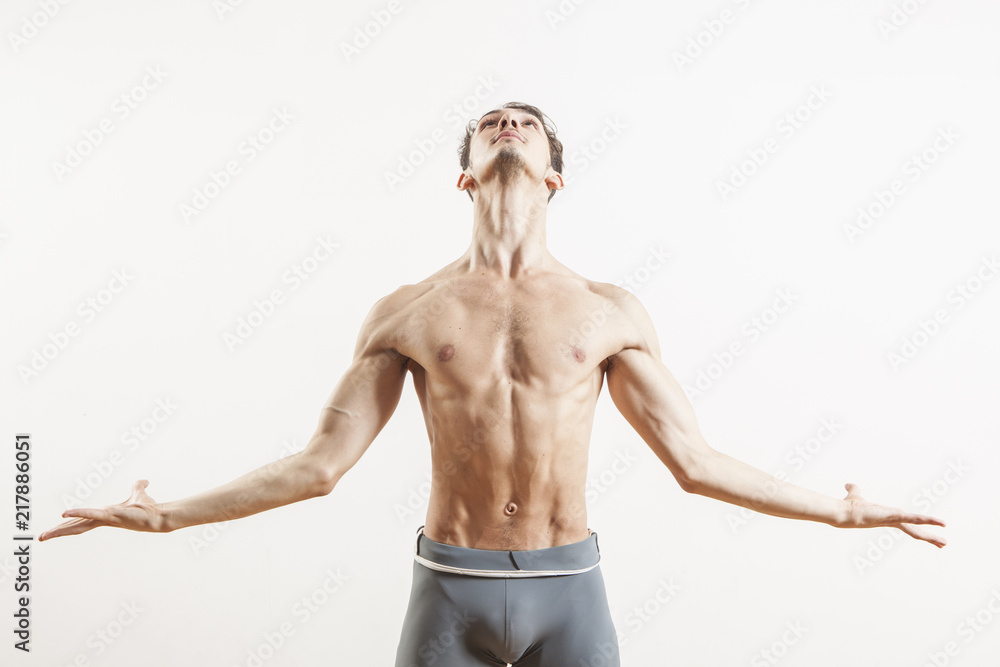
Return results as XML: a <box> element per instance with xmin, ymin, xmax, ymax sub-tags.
<box><xmin>463</xmin><ymin>182</ymin><xmax>555</xmax><ymax>279</ymax></box>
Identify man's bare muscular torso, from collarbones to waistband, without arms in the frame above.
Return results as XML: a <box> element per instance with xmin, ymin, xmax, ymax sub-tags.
<box><xmin>379</xmin><ymin>267</ymin><xmax>643</xmax><ymax>550</ymax></box>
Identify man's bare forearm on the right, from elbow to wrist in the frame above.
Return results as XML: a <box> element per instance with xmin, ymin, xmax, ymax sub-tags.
<box><xmin>685</xmin><ymin>450</ymin><xmax>848</xmax><ymax>526</ymax></box>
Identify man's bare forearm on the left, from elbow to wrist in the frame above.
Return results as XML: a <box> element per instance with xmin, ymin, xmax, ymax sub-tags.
<box><xmin>160</xmin><ymin>452</ymin><xmax>329</xmax><ymax>532</ymax></box>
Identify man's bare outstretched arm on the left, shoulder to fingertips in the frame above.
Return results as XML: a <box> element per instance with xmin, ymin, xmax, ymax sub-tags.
<box><xmin>38</xmin><ymin>297</ymin><xmax>406</xmax><ymax>541</ymax></box>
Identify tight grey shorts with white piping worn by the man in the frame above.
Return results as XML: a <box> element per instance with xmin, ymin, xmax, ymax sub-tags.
<box><xmin>395</xmin><ymin>526</ymin><xmax>621</xmax><ymax>667</ymax></box>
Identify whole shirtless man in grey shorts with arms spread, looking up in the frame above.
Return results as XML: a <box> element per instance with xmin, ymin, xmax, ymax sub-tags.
<box><xmin>39</xmin><ymin>103</ymin><xmax>945</xmax><ymax>667</ymax></box>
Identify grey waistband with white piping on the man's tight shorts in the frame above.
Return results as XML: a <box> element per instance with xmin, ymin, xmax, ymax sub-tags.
<box><xmin>413</xmin><ymin>526</ymin><xmax>601</xmax><ymax>578</ymax></box>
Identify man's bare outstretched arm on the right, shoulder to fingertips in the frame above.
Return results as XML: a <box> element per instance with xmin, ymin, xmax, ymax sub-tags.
<box><xmin>606</xmin><ymin>290</ymin><xmax>945</xmax><ymax>547</ymax></box>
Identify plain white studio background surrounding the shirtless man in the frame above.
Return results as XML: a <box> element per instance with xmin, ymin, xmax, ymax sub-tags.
<box><xmin>0</xmin><ymin>0</ymin><xmax>1000</xmax><ymax>667</ymax></box>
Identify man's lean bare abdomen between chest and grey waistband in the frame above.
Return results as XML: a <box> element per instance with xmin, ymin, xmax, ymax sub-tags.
<box><xmin>424</xmin><ymin>378</ymin><xmax>596</xmax><ymax>551</ymax></box>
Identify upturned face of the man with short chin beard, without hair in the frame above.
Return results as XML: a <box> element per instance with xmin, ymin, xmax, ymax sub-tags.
<box><xmin>459</xmin><ymin>109</ymin><xmax>561</xmax><ymax>197</ymax></box>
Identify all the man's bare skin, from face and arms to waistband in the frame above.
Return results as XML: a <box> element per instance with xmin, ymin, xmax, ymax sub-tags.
<box><xmin>39</xmin><ymin>109</ymin><xmax>945</xmax><ymax>550</ymax></box>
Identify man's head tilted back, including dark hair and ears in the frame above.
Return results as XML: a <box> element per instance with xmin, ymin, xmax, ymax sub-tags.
<box><xmin>458</xmin><ymin>102</ymin><xmax>563</xmax><ymax>201</ymax></box>
